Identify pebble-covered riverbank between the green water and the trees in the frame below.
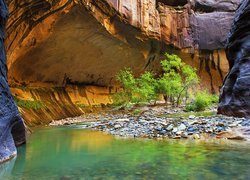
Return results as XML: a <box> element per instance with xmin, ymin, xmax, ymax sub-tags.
<box><xmin>50</xmin><ymin>107</ymin><xmax>250</xmax><ymax>140</ymax></box>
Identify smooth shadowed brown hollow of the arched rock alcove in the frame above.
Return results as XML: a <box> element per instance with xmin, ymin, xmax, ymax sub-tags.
<box><xmin>9</xmin><ymin>5</ymin><xmax>156</xmax><ymax>86</ymax></box>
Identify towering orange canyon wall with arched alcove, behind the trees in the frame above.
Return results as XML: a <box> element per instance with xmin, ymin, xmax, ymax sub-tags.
<box><xmin>2</xmin><ymin>0</ymin><xmax>240</xmax><ymax>123</ymax></box>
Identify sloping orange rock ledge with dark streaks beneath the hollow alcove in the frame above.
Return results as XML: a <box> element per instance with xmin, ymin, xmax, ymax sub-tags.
<box><xmin>11</xmin><ymin>85</ymin><xmax>116</xmax><ymax>127</ymax></box>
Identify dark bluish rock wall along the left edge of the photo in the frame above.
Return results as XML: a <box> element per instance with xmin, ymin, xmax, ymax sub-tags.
<box><xmin>0</xmin><ymin>0</ymin><xmax>25</xmax><ymax>163</ymax></box>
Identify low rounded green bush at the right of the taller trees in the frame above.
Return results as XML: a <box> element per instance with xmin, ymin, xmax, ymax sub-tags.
<box><xmin>186</xmin><ymin>91</ymin><xmax>219</xmax><ymax>111</ymax></box>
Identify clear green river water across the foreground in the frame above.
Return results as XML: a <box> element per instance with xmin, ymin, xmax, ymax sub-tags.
<box><xmin>0</xmin><ymin>126</ymin><xmax>250</xmax><ymax>180</ymax></box>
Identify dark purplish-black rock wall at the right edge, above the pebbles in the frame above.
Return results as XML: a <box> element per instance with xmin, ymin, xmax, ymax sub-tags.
<box><xmin>218</xmin><ymin>0</ymin><xmax>250</xmax><ymax>117</ymax></box>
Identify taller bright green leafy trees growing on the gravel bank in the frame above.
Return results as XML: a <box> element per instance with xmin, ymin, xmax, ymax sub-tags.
<box><xmin>113</xmin><ymin>54</ymin><xmax>199</xmax><ymax>106</ymax></box>
